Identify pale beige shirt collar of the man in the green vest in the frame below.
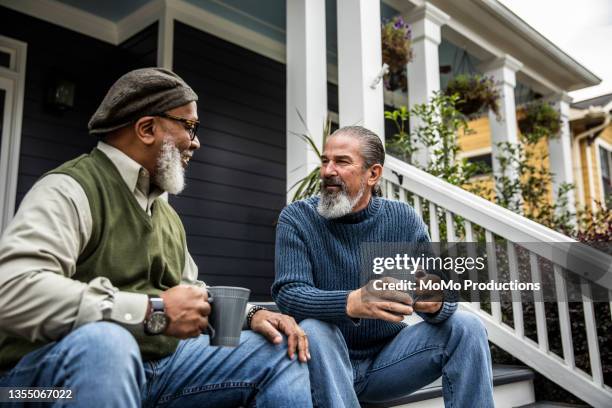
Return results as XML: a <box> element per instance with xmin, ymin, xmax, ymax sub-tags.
<box><xmin>96</xmin><ymin>141</ymin><xmax>163</xmax><ymax>198</ymax></box>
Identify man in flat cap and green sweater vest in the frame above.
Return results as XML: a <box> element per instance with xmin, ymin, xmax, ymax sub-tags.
<box><xmin>0</xmin><ymin>68</ymin><xmax>311</xmax><ymax>407</ymax></box>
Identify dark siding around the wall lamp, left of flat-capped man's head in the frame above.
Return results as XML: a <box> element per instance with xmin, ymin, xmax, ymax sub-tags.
<box><xmin>0</xmin><ymin>7</ymin><xmax>157</xmax><ymax>206</ymax></box>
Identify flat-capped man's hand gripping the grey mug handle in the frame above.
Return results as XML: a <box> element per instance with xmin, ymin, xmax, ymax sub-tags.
<box><xmin>160</xmin><ymin>285</ymin><xmax>210</xmax><ymax>339</ymax></box>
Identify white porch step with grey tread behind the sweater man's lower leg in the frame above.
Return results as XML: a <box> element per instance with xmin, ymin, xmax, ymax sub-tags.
<box><xmin>362</xmin><ymin>364</ymin><xmax>532</xmax><ymax>408</ymax></box>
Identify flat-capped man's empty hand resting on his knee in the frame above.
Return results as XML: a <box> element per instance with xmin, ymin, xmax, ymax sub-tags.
<box><xmin>251</xmin><ymin>310</ymin><xmax>310</xmax><ymax>363</ymax></box>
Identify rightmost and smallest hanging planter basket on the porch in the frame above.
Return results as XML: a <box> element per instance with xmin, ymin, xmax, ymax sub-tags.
<box><xmin>518</xmin><ymin>101</ymin><xmax>561</xmax><ymax>144</ymax></box>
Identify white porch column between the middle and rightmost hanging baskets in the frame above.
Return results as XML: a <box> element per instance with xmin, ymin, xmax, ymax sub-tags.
<box><xmin>481</xmin><ymin>55</ymin><xmax>523</xmax><ymax>192</ymax></box>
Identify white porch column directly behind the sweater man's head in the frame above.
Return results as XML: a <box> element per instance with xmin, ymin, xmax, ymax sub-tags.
<box><xmin>337</xmin><ymin>0</ymin><xmax>385</xmax><ymax>140</ymax></box>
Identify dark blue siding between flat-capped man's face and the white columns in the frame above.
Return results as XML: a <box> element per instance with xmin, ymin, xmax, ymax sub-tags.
<box><xmin>170</xmin><ymin>22</ymin><xmax>286</xmax><ymax>299</ymax></box>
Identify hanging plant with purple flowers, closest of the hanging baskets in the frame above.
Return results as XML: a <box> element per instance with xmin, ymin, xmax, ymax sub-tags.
<box><xmin>381</xmin><ymin>16</ymin><xmax>412</xmax><ymax>91</ymax></box>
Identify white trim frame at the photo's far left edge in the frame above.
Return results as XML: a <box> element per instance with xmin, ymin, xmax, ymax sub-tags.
<box><xmin>0</xmin><ymin>35</ymin><xmax>27</xmax><ymax>232</ymax></box>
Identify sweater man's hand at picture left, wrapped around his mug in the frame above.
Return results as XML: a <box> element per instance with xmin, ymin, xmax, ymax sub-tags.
<box><xmin>346</xmin><ymin>277</ymin><xmax>413</xmax><ymax>322</ymax></box>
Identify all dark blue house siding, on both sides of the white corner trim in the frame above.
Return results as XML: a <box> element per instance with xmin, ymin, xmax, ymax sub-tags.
<box><xmin>0</xmin><ymin>7</ymin><xmax>285</xmax><ymax>299</ymax></box>
